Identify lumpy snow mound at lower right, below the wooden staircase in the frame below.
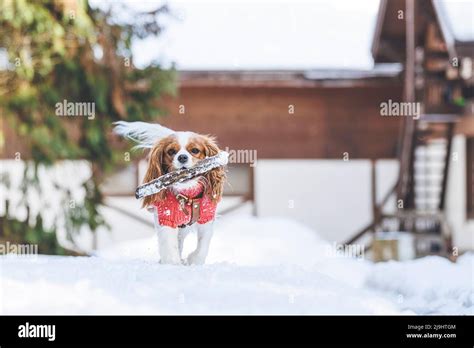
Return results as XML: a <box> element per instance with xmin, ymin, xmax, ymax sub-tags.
<box><xmin>366</xmin><ymin>253</ymin><xmax>474</xmax><ymax>315</ymax></box>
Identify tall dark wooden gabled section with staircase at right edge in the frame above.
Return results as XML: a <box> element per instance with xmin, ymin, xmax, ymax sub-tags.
<box><xmin>350</xmin><ymin>0</ymin><xmax>474</xmax><ymax>256</ymax></box>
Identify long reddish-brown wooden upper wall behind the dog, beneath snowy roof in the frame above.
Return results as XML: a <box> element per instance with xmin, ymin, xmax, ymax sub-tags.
<box><xmin>159</xmin><ymin>85</ymin><xmax>401</xmax><ymax>158</ymax></box>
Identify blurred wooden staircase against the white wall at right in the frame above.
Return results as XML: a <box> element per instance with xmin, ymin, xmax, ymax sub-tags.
<box><xmin>346</xmin><ymin>114</ymin><xmax>458</xmax><ymax>256</ymax></box>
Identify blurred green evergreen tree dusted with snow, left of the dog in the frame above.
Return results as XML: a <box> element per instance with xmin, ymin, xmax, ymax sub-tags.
<box><xmin>0</xmin><ymin>0</ymin><xmax>175</xmax><ymax>253</ymax></box>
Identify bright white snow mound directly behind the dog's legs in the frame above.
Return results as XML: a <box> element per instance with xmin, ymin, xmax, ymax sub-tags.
<box><xmin>97</xmin><ymin>216</ymin><xmax>334</xmax><ymax>266</ymax></box>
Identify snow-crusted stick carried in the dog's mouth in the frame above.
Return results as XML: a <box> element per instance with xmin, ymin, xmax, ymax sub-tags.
<box><xmin>135</xmin><ymin>151</ymin><xmax>229</xmax><ymax>199</ymax></box>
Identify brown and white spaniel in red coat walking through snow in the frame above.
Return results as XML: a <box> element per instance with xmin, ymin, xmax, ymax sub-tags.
<box><xmin>114</xmin><ymin>121</ymin><xmax>226</xmax><ymax>265</ymax></box>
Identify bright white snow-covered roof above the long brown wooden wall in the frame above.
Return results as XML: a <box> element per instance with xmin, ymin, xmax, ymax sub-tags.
<box><xmin>92</xmin><ymin>0</ymin><xmax>378</xmax><ymax>70</ymax></box>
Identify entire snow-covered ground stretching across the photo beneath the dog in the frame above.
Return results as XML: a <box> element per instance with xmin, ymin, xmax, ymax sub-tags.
<box><xmin>0</xmin><ymin>216</ymin><xmax>474</xmax><ymax>315</ymax></box>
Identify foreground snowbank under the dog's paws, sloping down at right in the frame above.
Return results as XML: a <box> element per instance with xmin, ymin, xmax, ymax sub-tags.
<box><xmin>0</xmin><ymin>256</ymin><xmax>399</xmax><ymax>314</ymax></box>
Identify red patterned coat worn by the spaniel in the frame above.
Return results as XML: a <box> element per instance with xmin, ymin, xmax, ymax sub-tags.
<box><xmin>153</xmin><ymin>184</ymin><xmax>217</xmax><ymax>228</ymax></box>
